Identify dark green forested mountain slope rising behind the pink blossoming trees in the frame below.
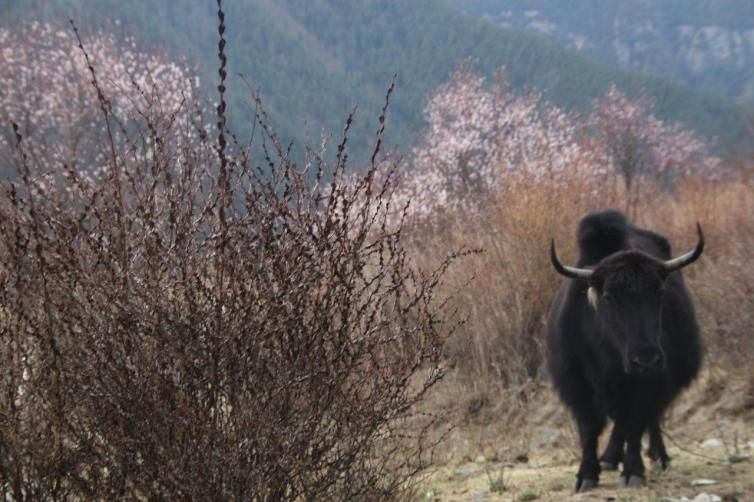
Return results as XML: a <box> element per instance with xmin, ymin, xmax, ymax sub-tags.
<box><xmin>0</xmin><ymin>0</ymin><xmax>743</xmax><ymax>159</ymax></box>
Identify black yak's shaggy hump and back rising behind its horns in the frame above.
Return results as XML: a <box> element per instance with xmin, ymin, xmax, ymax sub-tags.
<box><xmin>577</xmin><ymin>209</ymin><xmax>671</xmax><ymax>267</ymax></box>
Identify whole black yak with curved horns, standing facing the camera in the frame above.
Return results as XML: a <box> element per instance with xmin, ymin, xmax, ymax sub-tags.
<box><xmin>547</xmin><ymin>210</ymin><xmax>704</xmax><ymax>491</ymax></box>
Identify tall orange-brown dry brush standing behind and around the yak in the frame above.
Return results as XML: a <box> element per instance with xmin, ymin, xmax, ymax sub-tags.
<box><xmin>408</xmin><ymin>168</ymin><xmax>754</xmax><ymax>460</ymax></box>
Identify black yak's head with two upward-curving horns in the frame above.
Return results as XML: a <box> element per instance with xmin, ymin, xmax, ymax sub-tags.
<box><xmin>551</xmin><ymin>224</ymin><xmax>704</xmax><ymax>375</ymax></box>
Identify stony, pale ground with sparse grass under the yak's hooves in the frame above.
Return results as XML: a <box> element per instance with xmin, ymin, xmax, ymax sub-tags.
<box><xmin>417</xmin><ymin>369</ymin><xmax>754</xmax><ymax>502</ymax></box>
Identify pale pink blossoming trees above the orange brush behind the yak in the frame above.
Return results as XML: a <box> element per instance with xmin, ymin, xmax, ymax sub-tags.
<box><xmin>401</xmin><ymin>68</ymin><xmax>720</xmax><ymax>220</ymax></box>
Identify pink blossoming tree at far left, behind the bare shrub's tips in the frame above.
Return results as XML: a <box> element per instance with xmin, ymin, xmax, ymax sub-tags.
<box><xmin>0</xmin><ymin>22</ymin><xmax>198</xmax><ymax>191</ymax></box>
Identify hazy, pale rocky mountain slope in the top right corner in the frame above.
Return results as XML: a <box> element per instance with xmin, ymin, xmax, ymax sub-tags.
<box><xmin>451</xmin><ymin>0</ymin><xmax>754</xmax><ymax>101</ymax></box>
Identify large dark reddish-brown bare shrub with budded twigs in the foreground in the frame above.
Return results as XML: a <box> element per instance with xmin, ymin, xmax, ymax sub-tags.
<box><xmin>0</xmin><ymin>5</ymin><xmax>456</xmax><ymax>501</ymax></box>
